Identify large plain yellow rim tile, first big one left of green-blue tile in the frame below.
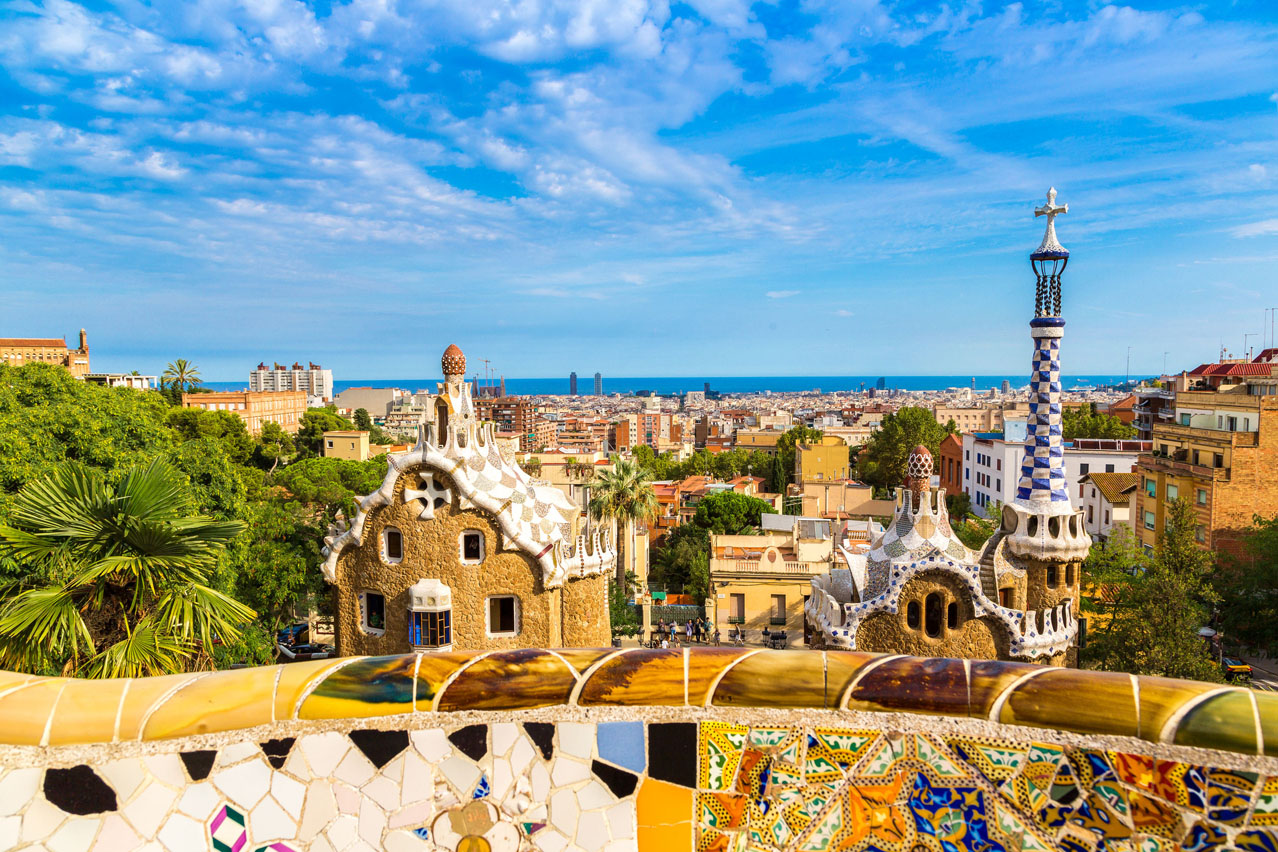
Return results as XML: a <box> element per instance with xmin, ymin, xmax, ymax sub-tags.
<box><xmin>142</xmin><ymin>666</ymin><xmax>280</xmax><ymax>740</ymax></box>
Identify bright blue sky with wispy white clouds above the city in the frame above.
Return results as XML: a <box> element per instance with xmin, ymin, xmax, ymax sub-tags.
<box><xmin>0</xmin><ymin>0</ymin><xmax>1278</xmax><ymax>379</ymax></box>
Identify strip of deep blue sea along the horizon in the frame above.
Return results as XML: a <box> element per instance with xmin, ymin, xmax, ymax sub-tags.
<box><xmin>204</xmin><ymin>373</ymin><xmax>1125</xmax><ymax>396</ymax></box>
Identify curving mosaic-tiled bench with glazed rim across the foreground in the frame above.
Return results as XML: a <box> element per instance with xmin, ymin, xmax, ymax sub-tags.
<box><xmin>0</xmin><ymin>648</ymin><xmax>1278</xmax><ymax>852</ymax></box>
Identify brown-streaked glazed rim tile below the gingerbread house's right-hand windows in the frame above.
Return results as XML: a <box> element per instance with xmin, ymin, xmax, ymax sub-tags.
<box><xmin>437</xmin><ymin>648</ymin><xmax>576</xmax><ymax>711</ymax></box>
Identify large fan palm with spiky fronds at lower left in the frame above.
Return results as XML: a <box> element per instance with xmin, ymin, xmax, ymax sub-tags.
<box><xmin>0</xmin><ymin>461</ymin><xmax>256</xmax><ymax>677</ymax></box>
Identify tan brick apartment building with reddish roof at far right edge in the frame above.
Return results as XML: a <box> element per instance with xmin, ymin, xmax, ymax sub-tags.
<box><xmin>1134</xmin><ymin>362</ymin><xmax>1278</xmax><ymax>553</ymax></box>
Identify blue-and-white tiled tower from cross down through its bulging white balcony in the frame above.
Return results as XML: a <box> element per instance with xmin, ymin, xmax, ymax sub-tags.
<box><xmin>1003</xmin><ymin>188</ymin><xmax>1091</xmax><ymax>562</ymax></box>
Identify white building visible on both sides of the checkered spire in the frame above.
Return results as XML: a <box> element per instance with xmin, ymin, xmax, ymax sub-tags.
<box><xmin>962</xmin><ymin>419</ymin><xmax>1150</xmax><ymax>516</ymax></box>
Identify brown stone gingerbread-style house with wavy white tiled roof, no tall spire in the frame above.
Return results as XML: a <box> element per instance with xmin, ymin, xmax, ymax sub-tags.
<box><xmin>323</xmin><ymin>346</ymin><xmax>616</xmax><ymax>655</ymax></box>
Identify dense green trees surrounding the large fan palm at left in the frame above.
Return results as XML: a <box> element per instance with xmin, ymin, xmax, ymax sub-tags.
<box><xmin>0</xmin><ymin>363</ymin><xmax>386</xmax><ymax>673</ymax></box>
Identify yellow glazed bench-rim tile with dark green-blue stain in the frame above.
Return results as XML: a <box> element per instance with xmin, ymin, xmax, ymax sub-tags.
<box><xmin>298</xmin><ymin>654</ymin><xmax>417</xmax><ymax>719</ymax></box>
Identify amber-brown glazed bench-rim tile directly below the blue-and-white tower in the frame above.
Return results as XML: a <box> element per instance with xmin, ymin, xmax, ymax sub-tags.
<box><xmin>998</xmin><ymin>668</ymin><xmax>1136</xmax><ymax>737</ymax></box>
